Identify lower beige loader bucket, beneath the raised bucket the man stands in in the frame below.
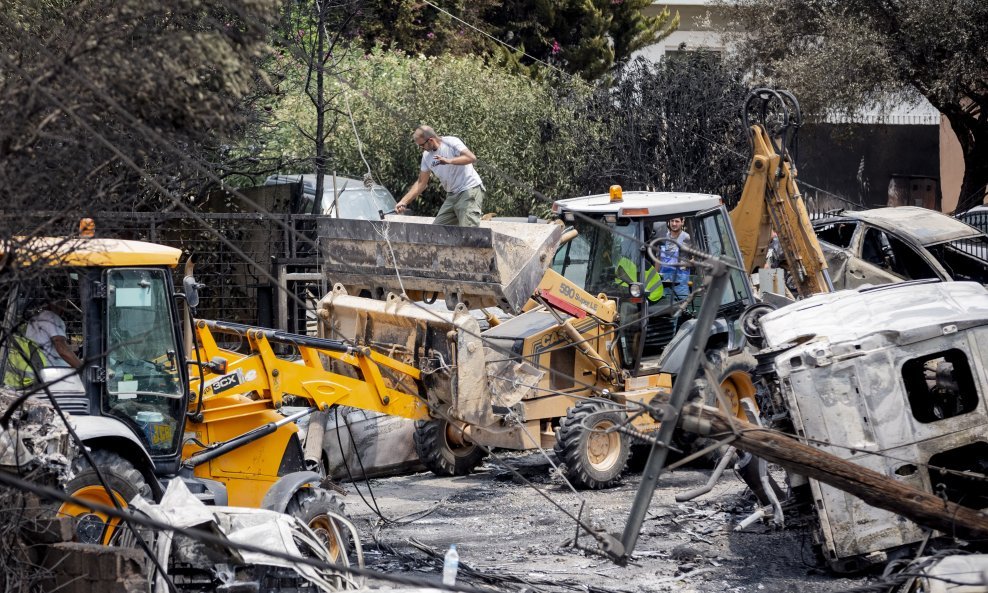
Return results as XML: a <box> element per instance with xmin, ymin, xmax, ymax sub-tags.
<box><xmin>319</xmin><ymin>284</ymin><xmax>543</xmax><ymax>426</ymax></box>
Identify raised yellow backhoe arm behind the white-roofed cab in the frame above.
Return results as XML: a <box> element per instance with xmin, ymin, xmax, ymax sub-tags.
<box><xmin>731</xmin><ymin>89</ymin><xmax>833</xmax><ymax>297</ymax></box>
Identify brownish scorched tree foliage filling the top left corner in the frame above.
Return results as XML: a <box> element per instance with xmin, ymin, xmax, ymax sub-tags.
<box><xmin>0</xmin><ymin>0</ymin><xmax>277</xmax><ymax>221</ymax></box>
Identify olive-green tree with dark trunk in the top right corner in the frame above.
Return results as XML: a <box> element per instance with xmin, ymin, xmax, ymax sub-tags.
<box><xmin>725</xmin><ymin>0</ymin><xmax>988</xmax><ymax>210</ymax></box>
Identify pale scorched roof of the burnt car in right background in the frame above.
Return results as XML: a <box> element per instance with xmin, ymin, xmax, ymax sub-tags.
<box><xmin>814</xmin><ymin>206</ymin><xmax>983</xmax><ymax>245</ymax></box>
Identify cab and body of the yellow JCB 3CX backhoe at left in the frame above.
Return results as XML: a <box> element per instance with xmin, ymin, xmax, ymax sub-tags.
<box><xmin>0</xmin><ymin>237</ymin><xmax>352</xmax><ymax>558</ymax></box>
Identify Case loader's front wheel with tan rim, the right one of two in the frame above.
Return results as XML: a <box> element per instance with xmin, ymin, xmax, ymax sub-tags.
<box><xmin>553</xmin><ymin>401</ymin><xmax>631</xmax><ymax>490</ymax></box>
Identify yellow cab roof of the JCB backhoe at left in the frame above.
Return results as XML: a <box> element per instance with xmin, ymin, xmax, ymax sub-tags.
<box><xmin>10</xmin><ymin>237</ymin><xmax>182</xmax><ymax>267</ymax></box>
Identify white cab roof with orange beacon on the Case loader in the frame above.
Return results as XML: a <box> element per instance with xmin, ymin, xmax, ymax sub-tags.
<box><xmin>552</xmin><ymin>191</ymin><xmax>722</xmax><ymax>216</ymax></box>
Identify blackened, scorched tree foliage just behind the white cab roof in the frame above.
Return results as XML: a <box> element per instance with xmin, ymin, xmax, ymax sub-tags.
<box><xmin>580</xmin><ymin>52</ymin><xmax>749</xmax><ymax>199</ymax></box>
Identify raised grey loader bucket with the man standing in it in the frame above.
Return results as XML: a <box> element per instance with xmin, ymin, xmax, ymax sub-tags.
<box><xmin>318</xmin><ymin>216</ymin><xmax>562</xmax><ymax>314</ymax></box>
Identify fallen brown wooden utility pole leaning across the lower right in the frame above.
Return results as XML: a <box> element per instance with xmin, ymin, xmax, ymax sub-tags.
<box><xmin>682</xmin><ymin>403</ymin><xmax>988</xmax><ymax>538</ymax></box>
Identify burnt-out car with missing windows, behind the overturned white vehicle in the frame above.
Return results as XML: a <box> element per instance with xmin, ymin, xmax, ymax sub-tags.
<box><xmin>813</xmin><ymin>206</ymin><xmax>988</xmax><ymax>289</ymax></box>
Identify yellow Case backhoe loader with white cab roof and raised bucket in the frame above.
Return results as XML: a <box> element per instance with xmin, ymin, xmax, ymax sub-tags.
<box><xmin>310</xmin><ymin>89</ymin><xmax>830</xmax><ymax>488</ymax></box>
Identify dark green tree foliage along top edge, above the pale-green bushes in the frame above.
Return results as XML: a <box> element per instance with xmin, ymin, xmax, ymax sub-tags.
<box><xmin>348</xmin><ymin>0</ymin><xmax>679</xmax><ymax>80</ymax></box>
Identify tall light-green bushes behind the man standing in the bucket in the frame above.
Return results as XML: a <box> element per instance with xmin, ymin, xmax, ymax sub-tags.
<box><xmin>244</xmin><ymin>48</ymin><xmax>603</xmax><ymax>215</ymax></box>
